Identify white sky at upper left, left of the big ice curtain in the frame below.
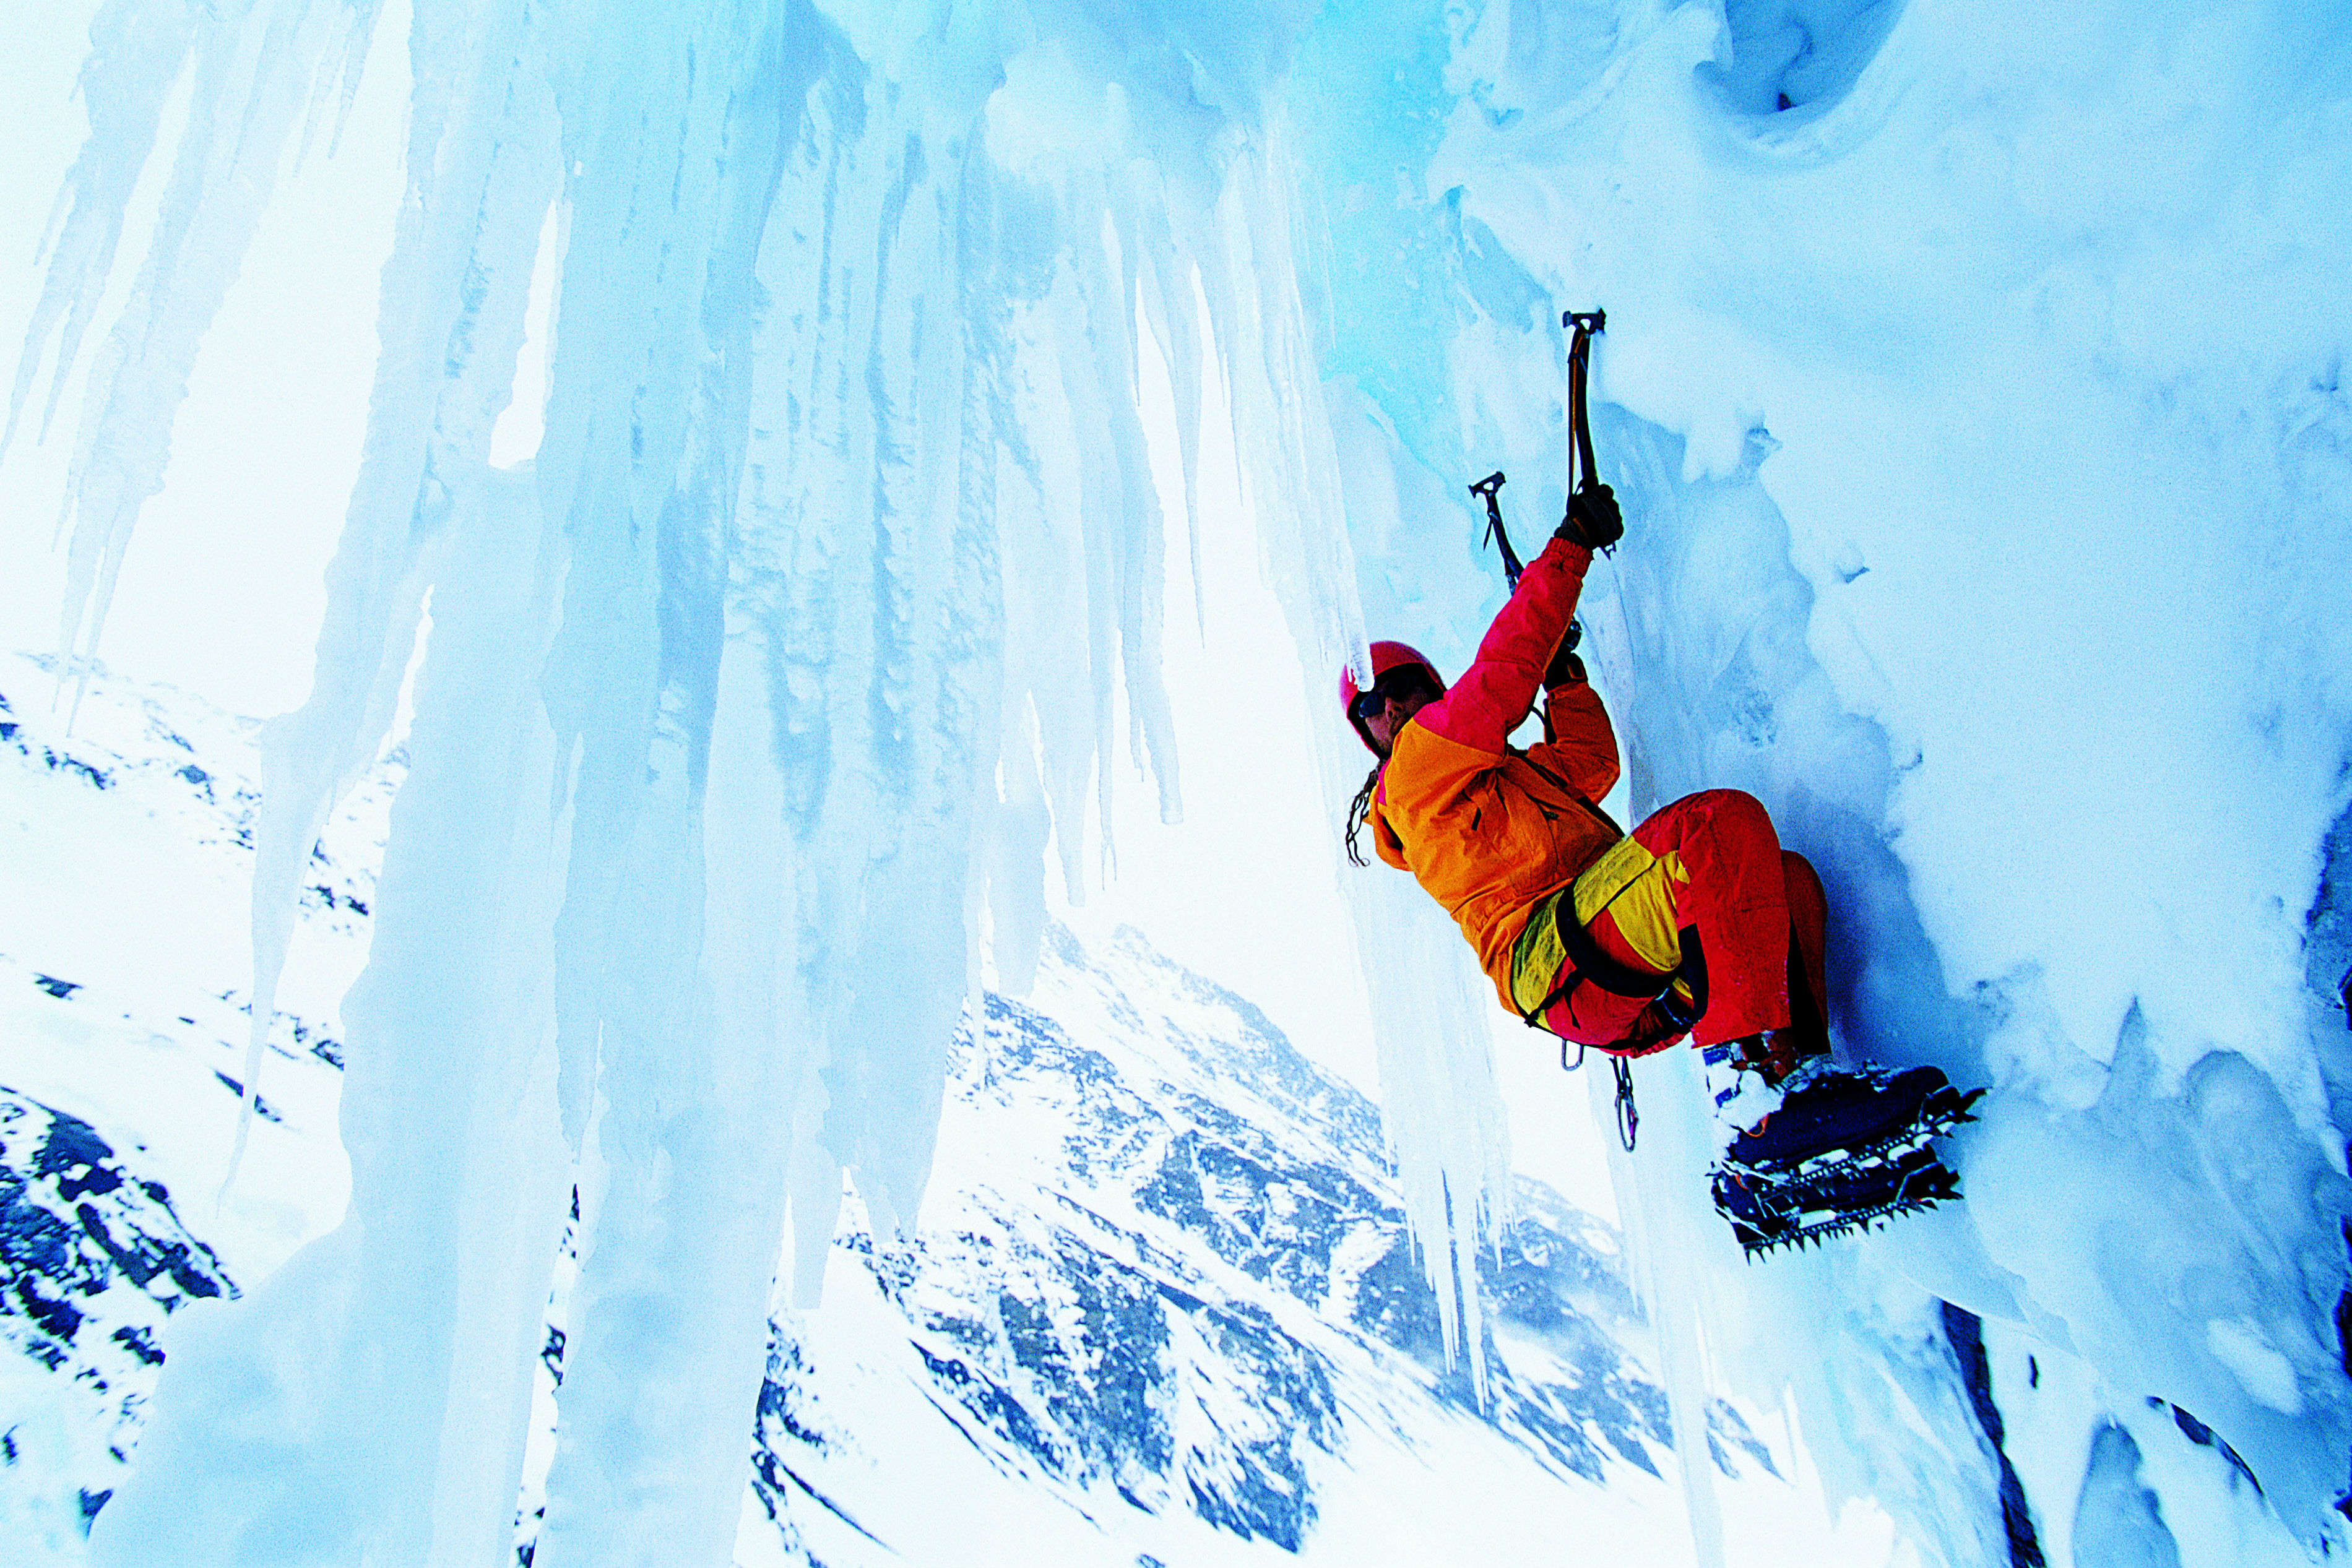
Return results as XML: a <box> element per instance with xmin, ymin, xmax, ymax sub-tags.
<box><xmin>0</xmin><ymin>0</ymin><xmax>407</xmax><ymax>715</ymax></box>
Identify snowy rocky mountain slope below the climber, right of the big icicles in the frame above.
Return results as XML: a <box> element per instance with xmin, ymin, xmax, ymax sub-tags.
<box><xmin>715</xmin><ymin>931</ymin><xmax>1778</xmax><ymax>1563</ymax></box>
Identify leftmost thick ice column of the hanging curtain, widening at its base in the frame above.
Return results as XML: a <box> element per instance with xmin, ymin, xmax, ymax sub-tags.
<box><xmin>94</xmin><ymin>5</ymin><xmax>583</xmax><ymax>1561</ymax></box>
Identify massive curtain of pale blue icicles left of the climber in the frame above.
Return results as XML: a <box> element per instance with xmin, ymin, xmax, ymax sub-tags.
<box><xmin>46</xmin><ymin>0</ymin><xmax>1347</xmax><ymax>1563</ymax></box>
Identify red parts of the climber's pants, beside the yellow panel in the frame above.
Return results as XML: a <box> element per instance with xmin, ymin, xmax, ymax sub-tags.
<box><xmin>1546</xmin><ymin>790</ymin><xmax>1830</xmax><ymax>1051</ymax></box>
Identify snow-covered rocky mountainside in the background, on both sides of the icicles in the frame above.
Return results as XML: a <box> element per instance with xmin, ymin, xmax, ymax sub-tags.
<box><xmin>0</xmin><ymin>658</ymin><xmax>1806</xmax><ymax>1568</ymax></box>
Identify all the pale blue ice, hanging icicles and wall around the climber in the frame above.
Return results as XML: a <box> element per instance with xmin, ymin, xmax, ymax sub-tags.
<box><xmin>18</xmin><ymin>0</ymin><xmax>2352</xmax><ymax>1563</ymax></box>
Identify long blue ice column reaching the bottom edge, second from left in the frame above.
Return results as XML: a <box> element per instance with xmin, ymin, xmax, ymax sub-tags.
<box><xmin>491</xmin><ymin>5</ymin><xmax>828</xmax><ymax>1563</ymax></box>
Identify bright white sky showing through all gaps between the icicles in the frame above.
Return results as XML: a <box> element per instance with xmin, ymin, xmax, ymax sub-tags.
<box><xmin>0</xmin><ymin>0</ymin><xmax>1614</xmax><ymax>1215</ymax></box>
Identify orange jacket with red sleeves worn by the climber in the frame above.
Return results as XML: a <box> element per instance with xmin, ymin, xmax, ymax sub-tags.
<box><xmin>1369</xmin><ymin>538</ymin><xmax>1625</xmax><ymax>1011</ymax></box>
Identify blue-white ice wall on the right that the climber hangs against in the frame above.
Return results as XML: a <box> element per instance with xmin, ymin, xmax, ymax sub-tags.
<box><xmin>1291</xmin><ymin>0</ymin><xmax>2352</xmax><ymax>1563</ymax></box>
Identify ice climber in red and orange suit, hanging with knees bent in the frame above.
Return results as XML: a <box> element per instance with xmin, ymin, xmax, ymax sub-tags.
<box><xmin>1341</xmin><ymin>485</ymin><xmax>1976</xmax><ymax>1251</ymax></box>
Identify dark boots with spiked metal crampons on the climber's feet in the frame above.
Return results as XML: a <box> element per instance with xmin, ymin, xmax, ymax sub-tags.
<box><xmin>1714</xmin><ymin>1067</ymin><xmax>1985</xmax><ymax>1260</ymax></box>
